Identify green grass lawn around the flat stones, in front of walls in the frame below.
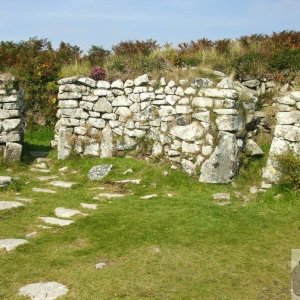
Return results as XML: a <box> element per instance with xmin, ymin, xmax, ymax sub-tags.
<box><xmin>0</xmin><ymin>129</ymin><xmax>300</xmax><ymax>300</ymax></box>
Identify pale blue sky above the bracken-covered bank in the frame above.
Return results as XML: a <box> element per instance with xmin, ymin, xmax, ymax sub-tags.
<box><xmin>0</xmin><ymin>0</ymin><xmax>300</xmax><ymax>50</ymax></box>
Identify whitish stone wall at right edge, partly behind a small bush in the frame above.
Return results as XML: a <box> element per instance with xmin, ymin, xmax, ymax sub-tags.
<box><xmin>263</xmin><ymin>91</ymin><xmax>300</xmax><ymax>188</ymax></box>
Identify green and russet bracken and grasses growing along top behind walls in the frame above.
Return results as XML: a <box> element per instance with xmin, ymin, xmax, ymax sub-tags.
<box><xmin>0</xmin><ymin>31</ymin><xmax>300</xmax><ymax>125</ymax></box>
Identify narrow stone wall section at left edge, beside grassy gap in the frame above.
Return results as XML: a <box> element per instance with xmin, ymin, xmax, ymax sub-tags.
<box><xmin>0</xmin><ymin>75</ymin><xmax>24</xmax><ymax>161</ymax></box>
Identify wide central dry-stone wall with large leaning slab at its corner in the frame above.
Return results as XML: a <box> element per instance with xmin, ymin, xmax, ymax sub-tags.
<box><xmin>54</xmin><ymin>75</ymin><xmax>257</xmax><ymax>183</ymax></box>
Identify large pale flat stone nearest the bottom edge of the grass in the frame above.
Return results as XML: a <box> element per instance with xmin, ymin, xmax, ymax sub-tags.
<box><xmin>19</xmin><ymin>281</ymin><xmax>69</xmax><ymax>300</ymax></box>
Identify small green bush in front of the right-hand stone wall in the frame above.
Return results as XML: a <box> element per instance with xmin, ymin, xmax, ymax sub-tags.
<box><xmin>275</xmin><ymin>152</ymin><xmax>300</xmax><ymax>189</ymax></box>
